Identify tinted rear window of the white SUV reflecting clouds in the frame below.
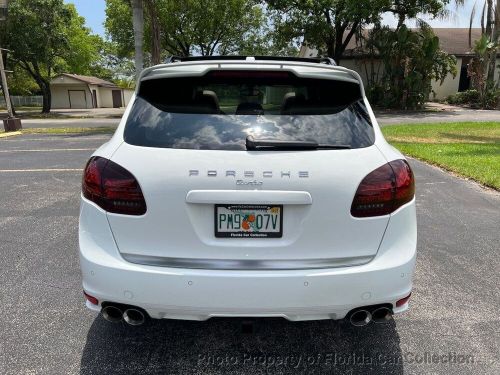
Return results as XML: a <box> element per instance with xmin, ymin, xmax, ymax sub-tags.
<box><xmin>125</xmin><ymin>71</ymin><xmax>374</xmax><ymax>150</ymax></box>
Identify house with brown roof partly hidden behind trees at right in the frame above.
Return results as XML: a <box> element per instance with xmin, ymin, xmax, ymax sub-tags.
<box><xmin>300</xmin><ymin>28</ymin><xmax>500</xmax><ymax>99</ymax></box>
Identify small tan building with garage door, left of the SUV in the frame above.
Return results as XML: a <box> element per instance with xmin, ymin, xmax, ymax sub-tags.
<box><xmin>50</xmin><ymin>73</ymin><xmax>134</xmax><ymax>109</ymax></box>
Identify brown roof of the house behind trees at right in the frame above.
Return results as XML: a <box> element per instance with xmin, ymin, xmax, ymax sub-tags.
<box><xmin>300</xmin><ymin>27</ymin><xmax>488</xmax><ymax>58</ymax></box>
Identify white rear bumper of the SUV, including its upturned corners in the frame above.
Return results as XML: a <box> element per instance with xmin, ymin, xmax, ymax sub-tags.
<box><xmin>80</xmin><ymin>200</ymin><xmax>416</xmax><ymax>320</ymax></box>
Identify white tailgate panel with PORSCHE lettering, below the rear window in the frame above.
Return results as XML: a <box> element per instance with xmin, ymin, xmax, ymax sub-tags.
<box><xmin>108</xmin><ymin>143</ymin><xmax>389</xmax><ymax>269</ymax></box>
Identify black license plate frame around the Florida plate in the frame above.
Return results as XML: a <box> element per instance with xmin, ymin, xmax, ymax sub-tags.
<box><xmin>214</xmin><ymin>204</ymin><xmax>283</xmax><ymax>239</ymax></box>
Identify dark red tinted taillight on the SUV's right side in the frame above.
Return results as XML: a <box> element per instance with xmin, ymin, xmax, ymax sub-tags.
<box><xmin>351</xmin><ymin>159</ymin><xmax>415</xmax><ymax>217</ymax></box>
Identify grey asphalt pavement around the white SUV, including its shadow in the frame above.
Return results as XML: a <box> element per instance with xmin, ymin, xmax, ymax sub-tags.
<box><xmin>0</xmin><ymin>135</ymin><xmax>500</xmax><ymax>374</ymax></box>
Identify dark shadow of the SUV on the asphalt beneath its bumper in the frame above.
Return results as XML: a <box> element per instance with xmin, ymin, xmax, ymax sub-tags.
<box><xmin>81</xmin><ymin>316</ymin><xmax>403</xmax><ymax>375</ymax></box>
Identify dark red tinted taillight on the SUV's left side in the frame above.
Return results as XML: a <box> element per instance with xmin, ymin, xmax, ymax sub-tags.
<box><xmin>82</xmin><ymin>156</ymin><xmax>146</xmax><ymax>215</ymax></box>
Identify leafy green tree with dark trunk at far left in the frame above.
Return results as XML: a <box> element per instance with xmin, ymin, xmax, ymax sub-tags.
<box><xmin>2</xmin><ymin>0</ymin><xmax>105</xmax><ymax>113</ymax></box>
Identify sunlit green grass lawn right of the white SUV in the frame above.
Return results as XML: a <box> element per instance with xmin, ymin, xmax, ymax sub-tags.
<box><xmin>382</xmin><ymin>122</ymin><xmax>500</xmax><ymax>190</ymax></box>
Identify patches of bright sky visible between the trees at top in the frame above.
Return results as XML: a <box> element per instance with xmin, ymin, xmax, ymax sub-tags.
<box><xmin>65</xmin><ymin>0</ymin><xmax>482</xmax><ymax>36</ymax></box>
